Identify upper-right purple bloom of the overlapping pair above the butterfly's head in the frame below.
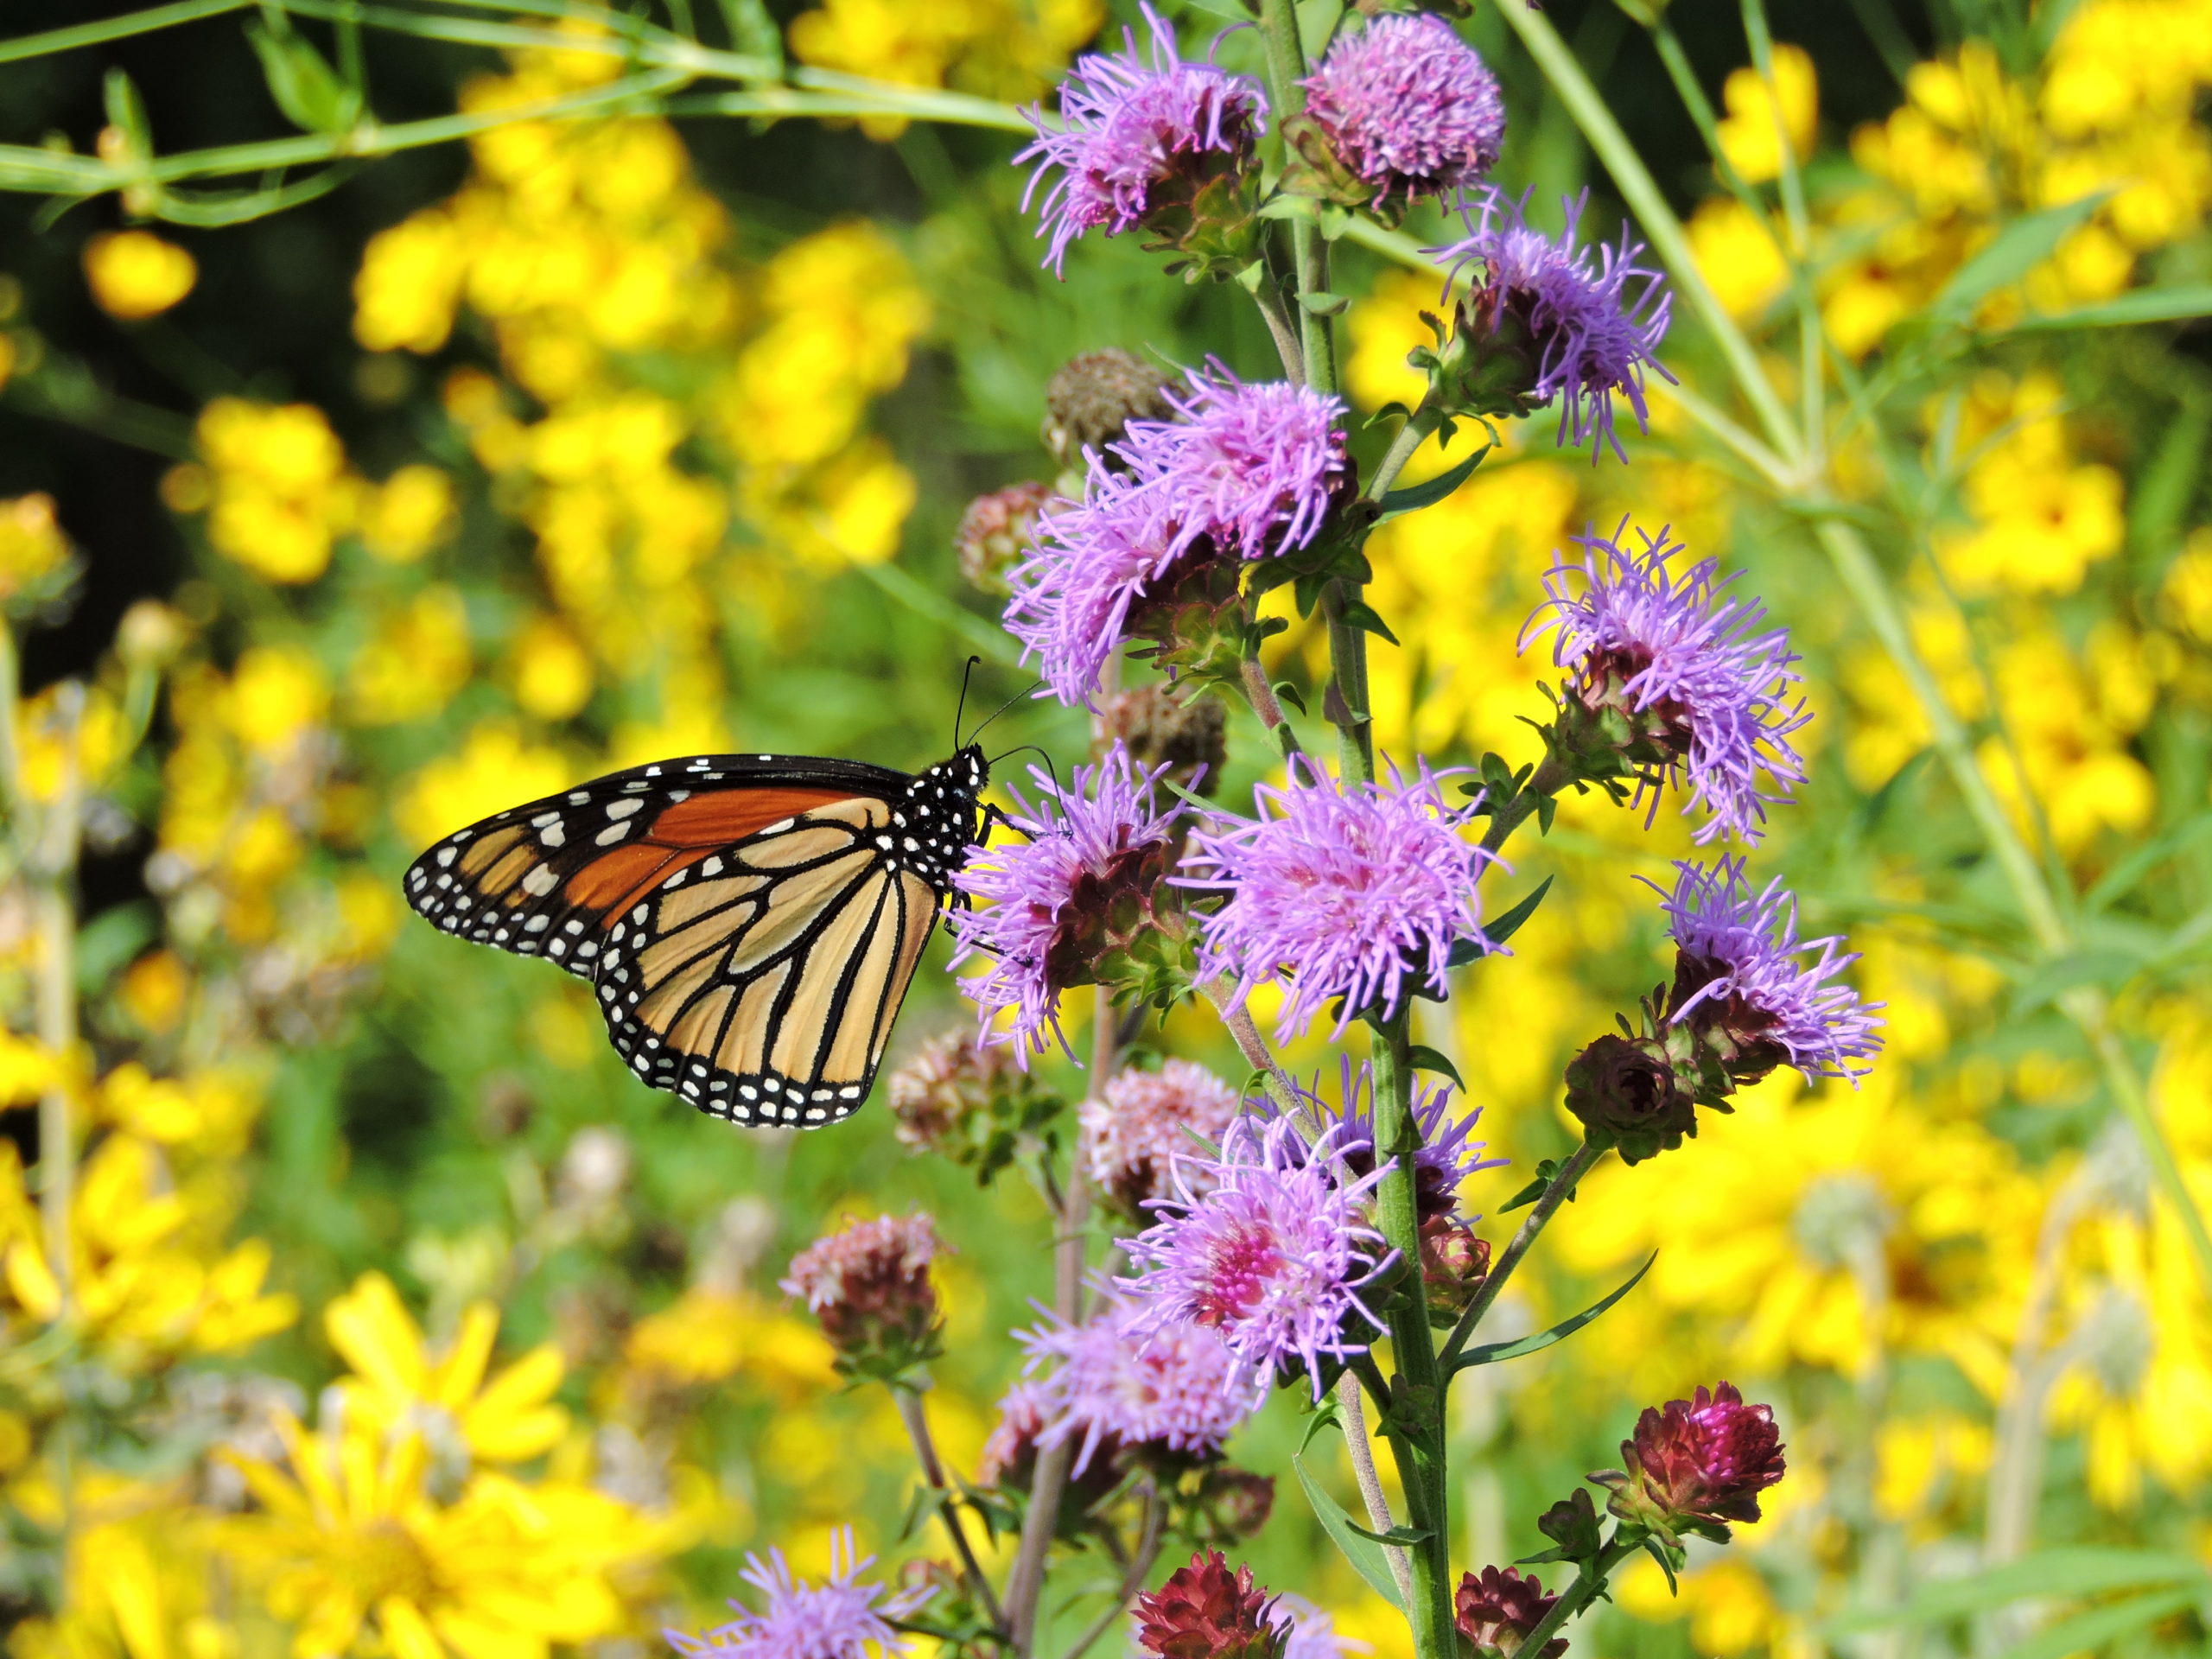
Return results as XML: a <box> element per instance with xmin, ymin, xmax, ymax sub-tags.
<box><xmin>1113</xmin><ymin>363</ymin><xmax>1351</xmax><ymax>560</ymax></box>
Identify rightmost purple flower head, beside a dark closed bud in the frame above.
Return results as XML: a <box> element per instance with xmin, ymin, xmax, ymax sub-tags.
<box><xmin>1659</xmin><ymin>858</ymin><xmax>1883</xmax><ymax>1084</ymax></box>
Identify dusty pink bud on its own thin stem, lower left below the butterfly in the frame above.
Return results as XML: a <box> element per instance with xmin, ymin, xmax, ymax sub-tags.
<box><xmin>781</xmin><ymin>1214</ymin><xmax>944</xmax><ymax>1380</ymax></box>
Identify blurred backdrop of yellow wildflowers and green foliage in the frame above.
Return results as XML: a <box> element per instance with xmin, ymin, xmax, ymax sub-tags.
<box><xmin>0</xmin><ymin>0</ymin><xmax>2212</xmax><ymax>1659</ymax></box>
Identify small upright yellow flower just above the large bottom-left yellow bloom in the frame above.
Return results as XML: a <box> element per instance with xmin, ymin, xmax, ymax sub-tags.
<box><xmin>323</xmin><ymin>1272</ymin><xmax>569</xmax><ymax>1462</ymax></box>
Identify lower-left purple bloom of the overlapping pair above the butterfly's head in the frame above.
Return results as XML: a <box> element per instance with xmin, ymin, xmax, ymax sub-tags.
<box><xmin>1004</xmin><ymin>454</ymin><xmax>1192</xmax><ymax>706</ymax></box>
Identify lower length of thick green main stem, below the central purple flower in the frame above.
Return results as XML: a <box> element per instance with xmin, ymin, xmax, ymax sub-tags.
<box><xmin>1370</xmin><ymin>1008</ymin><xmax>1458</xmax><ymax>1659</ymax></box>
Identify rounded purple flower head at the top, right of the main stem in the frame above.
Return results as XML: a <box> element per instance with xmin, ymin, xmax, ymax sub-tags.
<box><xmin>1305</xmin><ymin>13</ymin><xmax>1506</xmax><ymax>201</ymax></box>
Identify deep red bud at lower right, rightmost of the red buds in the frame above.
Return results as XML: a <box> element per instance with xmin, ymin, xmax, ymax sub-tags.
<box><xmin>1591</xmin><ymin>1382</ymin><xmax>1785</xmax><ymax>1544</ymax></box>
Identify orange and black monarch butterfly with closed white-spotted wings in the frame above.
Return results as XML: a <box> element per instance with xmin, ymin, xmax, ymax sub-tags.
<box><xmin>407</xmin><ymin>741</ymin><xmax>991</xmax><ymax>1128</ymax></box>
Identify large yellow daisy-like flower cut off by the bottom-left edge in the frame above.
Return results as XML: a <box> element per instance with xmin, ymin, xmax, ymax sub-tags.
<box><xmin>224</xmin><ymin>1414</ymin><xmax>677</xmax><ymax>1659</ymax></box>
